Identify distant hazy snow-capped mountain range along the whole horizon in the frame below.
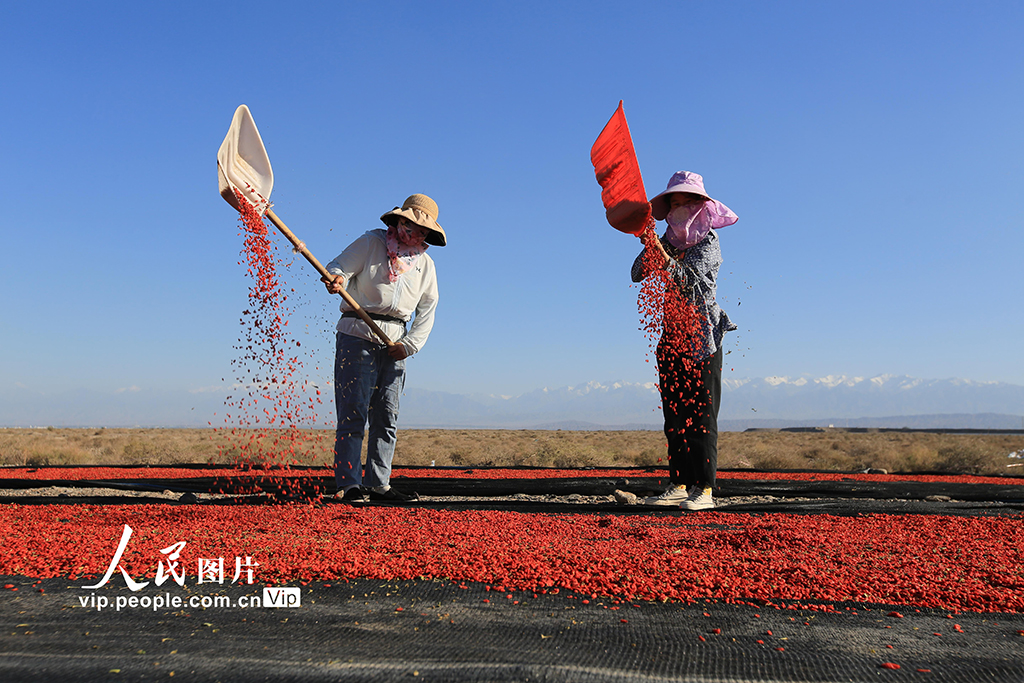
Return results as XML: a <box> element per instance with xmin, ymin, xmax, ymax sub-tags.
<box><xmin>0</xmin><ymin>375</ymin><xmax>1024</xmax><ymax>430</ymax></box>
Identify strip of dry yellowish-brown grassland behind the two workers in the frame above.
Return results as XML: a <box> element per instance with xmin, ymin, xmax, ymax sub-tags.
<box><xmin>0</xmin><ymin>427</ymin><xmax>1024</xmax><ymax>474</ymax></box>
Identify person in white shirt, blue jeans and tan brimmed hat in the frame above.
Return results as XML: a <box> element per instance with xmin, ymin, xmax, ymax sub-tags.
<box><xmin>324</xmin><ymin>195</ymin><xmax>447</xmax><ymax>502</ymax></box>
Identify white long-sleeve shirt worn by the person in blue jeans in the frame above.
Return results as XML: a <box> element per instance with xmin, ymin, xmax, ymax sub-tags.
<box><xmin>327</xmin><ymin>228</ymin><xmax>437</xmax><ymax>355</ymax></box>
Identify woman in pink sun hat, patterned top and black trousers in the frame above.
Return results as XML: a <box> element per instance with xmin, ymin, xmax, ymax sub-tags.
<box><xmin>632</xmin><ymin>171</ymin><xmax>737</xmax><ymax>510</ymax></box>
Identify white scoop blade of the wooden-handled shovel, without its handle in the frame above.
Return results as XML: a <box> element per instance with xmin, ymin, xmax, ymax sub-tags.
<box><xmin>217</xmin><ymin>104</ymin><xmax>273</xmax><ymax>215</ymax></box>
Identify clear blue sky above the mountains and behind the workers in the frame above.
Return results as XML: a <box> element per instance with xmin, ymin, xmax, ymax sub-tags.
<box><xmin>0</xmin><ymin>1</ymin><xmax>1024</xmax><ymax>421</ymax></box>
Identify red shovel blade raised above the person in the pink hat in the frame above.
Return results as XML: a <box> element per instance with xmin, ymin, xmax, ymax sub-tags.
<box><xmin>590</xmin><ymin>100</ymin><xmax>650</xmax><ymax>234</ymax></box>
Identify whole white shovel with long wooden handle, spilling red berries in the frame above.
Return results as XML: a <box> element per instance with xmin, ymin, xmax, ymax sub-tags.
<box><xmin>217</xmin><ymin>104</ymin><xmax>394</xmax><ymax>346</ymax></box>
